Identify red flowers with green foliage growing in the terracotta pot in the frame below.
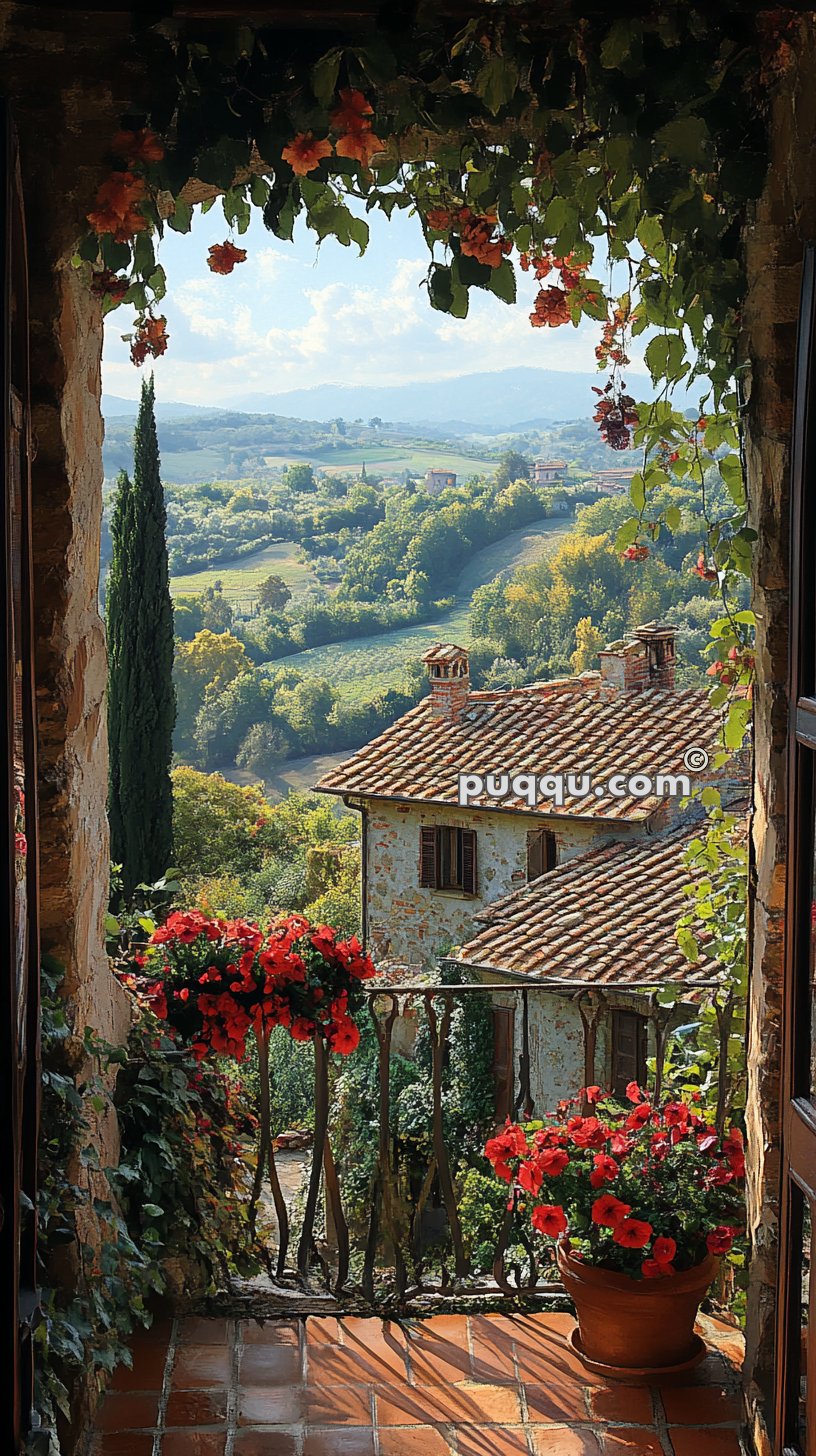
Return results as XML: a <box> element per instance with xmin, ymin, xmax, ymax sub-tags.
<box><xmin>485</xmin><ymin>1082</ymin><xmax>745</xmax><ymax>1278</ymax></box>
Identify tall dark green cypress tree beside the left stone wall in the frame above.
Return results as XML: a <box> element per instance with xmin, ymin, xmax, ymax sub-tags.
<box><xmin>105</xmin><ymin>379</ymin><xmax>176</xmax><ymax>898</ymax></box>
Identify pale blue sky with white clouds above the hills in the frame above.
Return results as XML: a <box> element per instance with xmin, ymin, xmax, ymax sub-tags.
<box><xmin>103</xmin><ymin>204</ymin><xmax>643</xmax><ymax>406</ymax></box>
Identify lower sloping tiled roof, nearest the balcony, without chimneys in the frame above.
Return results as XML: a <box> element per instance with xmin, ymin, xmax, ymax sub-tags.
<box><xmin>456</xmin><ymin>823</ymin><xmax>728</xmax><ymax>990</ymax></box>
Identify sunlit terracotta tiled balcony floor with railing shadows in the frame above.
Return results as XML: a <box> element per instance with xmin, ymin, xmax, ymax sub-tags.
<box><xmin>92</xmin><ymin>1313</ymin><xmax>742</xmax><ymax>1456</ymax></box>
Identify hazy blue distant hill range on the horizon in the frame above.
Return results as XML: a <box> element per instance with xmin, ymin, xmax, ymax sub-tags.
<box><xmin>102</xmin><ymin>368</ymin><xmax>681</xmax><ymax>434</ymax></box>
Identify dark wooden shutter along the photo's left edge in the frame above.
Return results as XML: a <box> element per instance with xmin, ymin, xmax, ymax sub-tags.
<box><xmin>0</xmin><ymin>102</ymin><xmax>41</xmax><ymax>1452</ymax></box>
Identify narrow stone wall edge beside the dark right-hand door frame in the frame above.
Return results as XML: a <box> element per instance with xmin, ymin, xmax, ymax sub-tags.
<box><xmin>743</xmin><ymin>12</ymin><xmax>816</xmax><ymax>1452</ymax></box>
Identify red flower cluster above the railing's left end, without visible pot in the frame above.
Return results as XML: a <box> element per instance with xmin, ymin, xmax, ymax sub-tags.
<box><xmin>122</xmin><ymin>910</ymin><xmax>374</xmax><ymax>1061</ymax></box>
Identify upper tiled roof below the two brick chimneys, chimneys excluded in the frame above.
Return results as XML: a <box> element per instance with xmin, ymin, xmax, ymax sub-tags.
<box><xmin>316</xmin><ymin>673</ymin><xmax>740</xmax><ymax>821</ymax></box>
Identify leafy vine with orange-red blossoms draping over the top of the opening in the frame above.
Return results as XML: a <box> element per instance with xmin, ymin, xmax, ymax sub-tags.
<box><xmin>76</xmin><ymin>8</ymin><xmax>796</xmax><ymax>747</ymax></box>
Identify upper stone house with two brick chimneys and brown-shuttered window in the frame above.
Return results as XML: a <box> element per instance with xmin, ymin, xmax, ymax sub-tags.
<box><xmin>316</xmin><ymin>623</ymin><xmax>740</xmax><ymax>962</ymax></box>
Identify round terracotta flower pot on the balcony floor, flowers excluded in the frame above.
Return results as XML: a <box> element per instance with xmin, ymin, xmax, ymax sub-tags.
<box><xmin>557</xmin><ymin>1243</ymin><xmax>717</xmax><ymax>1383</ymax></box>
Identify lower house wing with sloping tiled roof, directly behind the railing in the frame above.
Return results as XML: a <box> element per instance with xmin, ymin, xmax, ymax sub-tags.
<box><xmin>449</xmin><ymin>824</ymin><xmax>728</xmax><ymax>1118</ymax></box>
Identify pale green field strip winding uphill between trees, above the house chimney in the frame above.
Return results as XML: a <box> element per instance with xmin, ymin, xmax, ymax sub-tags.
<box><xmin>271</xmin><ymin>517</ymin><xmax>573</xmax><ymax>702</ymax></box>
